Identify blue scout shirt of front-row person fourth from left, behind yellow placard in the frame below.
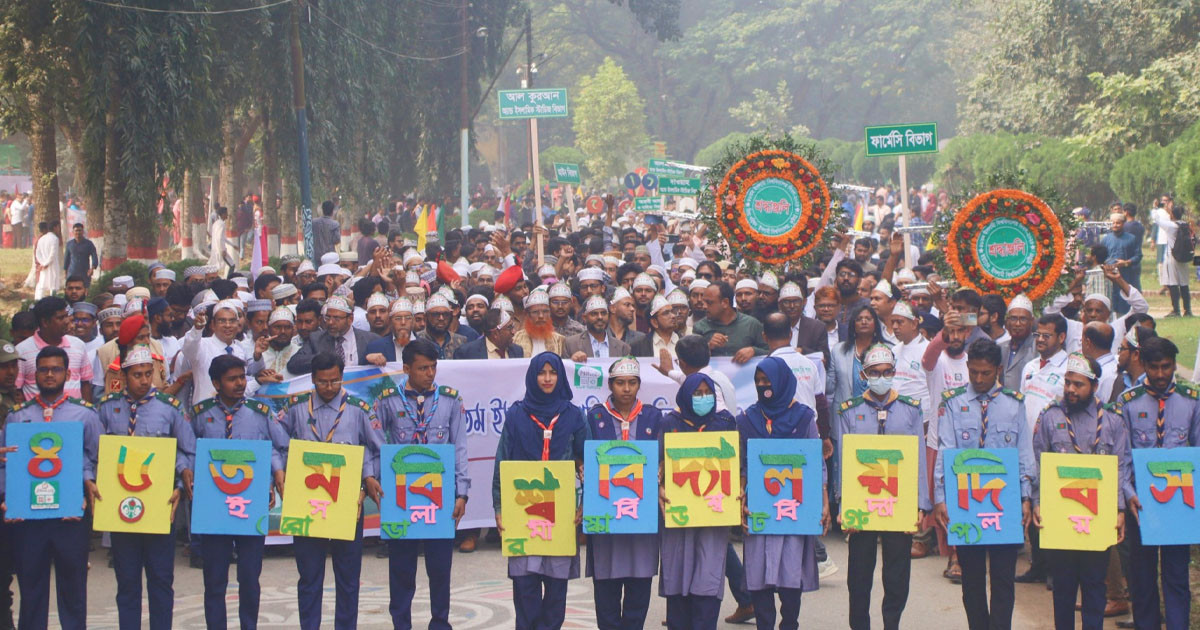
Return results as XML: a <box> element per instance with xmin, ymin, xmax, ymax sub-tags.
<box><xmin>283</xmin><ymin>389</ymin><xmax>383</xmax><ymax>480</ymax></box>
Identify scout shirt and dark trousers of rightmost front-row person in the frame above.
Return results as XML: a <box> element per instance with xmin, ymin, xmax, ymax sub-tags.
<box><xmin>1117</xmin><ymin>383</ymin><xmax>1200</xmax><ymax>629</ymax></box>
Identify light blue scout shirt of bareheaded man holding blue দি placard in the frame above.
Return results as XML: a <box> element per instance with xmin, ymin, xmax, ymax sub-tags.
<box><xmin>934</xmin><ymin>385</ymin><xmax>1038</xmax><ymax>503</ymax></box>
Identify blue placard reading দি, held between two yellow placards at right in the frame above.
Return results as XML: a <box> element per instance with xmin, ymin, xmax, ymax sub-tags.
<box><xmin>942</xmin><ymin>449</ymin><xmax>1025</xmax><ymax>545</ymax></box>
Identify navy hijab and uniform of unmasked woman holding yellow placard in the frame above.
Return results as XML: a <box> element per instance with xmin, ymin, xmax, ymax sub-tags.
<box><xmin>492</xmin><ymin>352</ymin><xmax>588</xmax><ymax>630</ymax></box>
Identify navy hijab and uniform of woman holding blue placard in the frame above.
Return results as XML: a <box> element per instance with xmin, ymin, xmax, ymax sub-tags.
<box><xmin>737</xmin><ymin>358</ymin><xmax>826</xmax><ymax>630</ymax></box>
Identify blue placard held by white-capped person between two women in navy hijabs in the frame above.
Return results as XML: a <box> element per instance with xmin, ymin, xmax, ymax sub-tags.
<box><xmin>583</xmin><ymin>439</ymin><xmax>659</xmax><ymax>534</ymax></box>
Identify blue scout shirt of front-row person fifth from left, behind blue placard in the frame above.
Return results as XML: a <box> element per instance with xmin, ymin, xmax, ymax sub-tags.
<box><xmin>374</xmin><ymin>382</ymin><xmax>470</xmax><ymax>498</ymax></box>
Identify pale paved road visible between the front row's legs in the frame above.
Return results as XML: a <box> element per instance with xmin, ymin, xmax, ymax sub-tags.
<box><xmin>21</xmin><ymin>535</ymin><xmax>1142</xmax><ymax>630</ymax></box>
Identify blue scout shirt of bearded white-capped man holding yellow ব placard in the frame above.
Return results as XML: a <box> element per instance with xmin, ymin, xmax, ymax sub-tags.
<box><xmin>1033</xmin><ymin>398</ymin><xmax>1135</xmax><ymax>510</ymax></box>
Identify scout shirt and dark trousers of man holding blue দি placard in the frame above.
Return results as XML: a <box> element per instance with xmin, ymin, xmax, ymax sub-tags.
<box><xmin>934</xmin><ymin>383</ymin><xmax>1032</xmax><ymax>629</ymax></box>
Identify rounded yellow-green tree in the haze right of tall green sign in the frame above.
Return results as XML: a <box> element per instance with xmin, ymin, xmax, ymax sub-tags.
<box><xmin>574</xmin><ymin>58</ymin><xmax>649</xmax><ymax>180</ymax></box>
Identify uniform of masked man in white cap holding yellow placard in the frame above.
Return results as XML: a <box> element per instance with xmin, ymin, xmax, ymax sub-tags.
<box><xmin>835</xmin><ymin>391</ymin><xmax>930</xmax><ymax>630</ymax></box>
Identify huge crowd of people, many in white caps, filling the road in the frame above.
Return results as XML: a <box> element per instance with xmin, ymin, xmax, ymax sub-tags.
<box><xmin>0</xmin><ymin>191</ymin><xmax>1200</xmax><ymax>629</ymax></box>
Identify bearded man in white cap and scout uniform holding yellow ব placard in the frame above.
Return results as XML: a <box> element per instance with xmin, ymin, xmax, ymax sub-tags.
<box><xmin>1032</xmin><ymin>348</ymin><xmax>1132</xmax><ymax>629</ymax></box>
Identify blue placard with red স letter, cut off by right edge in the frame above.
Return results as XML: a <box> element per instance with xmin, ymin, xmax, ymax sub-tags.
<box><xmin>1133</xmin><ymin>446</ymin><xmax>1200</xmax><ymax>545</ymax></box>
